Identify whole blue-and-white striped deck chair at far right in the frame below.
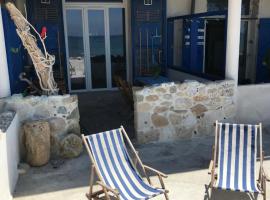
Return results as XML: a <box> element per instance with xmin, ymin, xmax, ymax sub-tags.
<box><xmin>209</xmin><ymin>122</ymin><xmax>267</xmax><ymax>199</ymax></box>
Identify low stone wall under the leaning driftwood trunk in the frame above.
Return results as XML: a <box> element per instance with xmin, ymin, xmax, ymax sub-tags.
<box><xmin>0</xmin><ymin>95</ymin><xmax>82</xmax><ymax>158</ymax></box>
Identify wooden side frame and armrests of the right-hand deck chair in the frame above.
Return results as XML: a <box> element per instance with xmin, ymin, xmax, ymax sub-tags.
<box><xmin>208</xmin><ymin>121</ymin><xmax>270</xmax><ymax>200</ymax></box>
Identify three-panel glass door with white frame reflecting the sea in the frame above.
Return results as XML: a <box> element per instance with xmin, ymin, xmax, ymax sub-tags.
<box><xmin>66</xmin><ymin>6</ymin><xmax>127</xmax><ymax>91</ymax></box>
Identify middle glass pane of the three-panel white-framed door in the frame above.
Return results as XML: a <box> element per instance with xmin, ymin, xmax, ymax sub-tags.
<box><xmin>88</xmin><ymin>10</ymin><xmax>107</xmax><ymax>89</ymax></box>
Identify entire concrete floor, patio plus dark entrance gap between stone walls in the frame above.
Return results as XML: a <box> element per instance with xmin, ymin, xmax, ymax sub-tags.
<box><xmin>11</xmin><ymin>92</ymin><xmax>270</xmax><ymax>200</ymax></box>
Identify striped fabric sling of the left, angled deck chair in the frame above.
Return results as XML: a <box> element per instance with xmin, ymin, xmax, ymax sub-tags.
<box><xmin>87</xmin><ymin>129</ymin><xmax>164</xmax><ymax>200</ymax></box>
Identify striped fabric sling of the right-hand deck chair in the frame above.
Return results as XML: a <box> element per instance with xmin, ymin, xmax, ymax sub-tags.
<box><xmin>216</xmin><ymin>123</ymin><xmax>259</xmax><ymax>193</ymax></box>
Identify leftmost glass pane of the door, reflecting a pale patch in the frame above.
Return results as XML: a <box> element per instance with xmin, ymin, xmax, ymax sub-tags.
<box><xmin>66</xmin><ymin>10</ymin><xmax>86</xmax><ymax>90</ymax></box>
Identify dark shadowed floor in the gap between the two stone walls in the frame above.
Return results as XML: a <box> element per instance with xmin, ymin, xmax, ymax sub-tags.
<box><xmin>78</xmin><ymin>91</ymin><xmax>134</xmax><ymax>138</ymax></box>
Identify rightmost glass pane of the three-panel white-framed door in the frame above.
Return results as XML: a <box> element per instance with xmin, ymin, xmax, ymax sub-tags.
<box><xmin>109</xmin><ymin>8</ymin><xmax>126</xmax><ymax>87</ymax></box>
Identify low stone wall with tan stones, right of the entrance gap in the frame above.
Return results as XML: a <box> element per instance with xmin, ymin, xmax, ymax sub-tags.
<box><xmin>134</xmin><ymin>81</ymin><xmax>236</xmax><ymax>143</ymax></box>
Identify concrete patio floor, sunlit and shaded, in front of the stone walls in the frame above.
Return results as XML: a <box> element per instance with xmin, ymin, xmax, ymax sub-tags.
<box><xmin>15</xmin><ymin>135</ymin><xmax>270</xmax><ymax>200</ymax></box>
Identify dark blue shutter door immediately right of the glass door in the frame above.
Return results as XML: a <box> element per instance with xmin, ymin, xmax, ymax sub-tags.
<box><xmin>132</xmin><ymin>0</ymin><xmax>166</xmax><ymax>77</ymax></box>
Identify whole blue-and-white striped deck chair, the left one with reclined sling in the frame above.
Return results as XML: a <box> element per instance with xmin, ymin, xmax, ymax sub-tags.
<box><xmin>82</xmin><ymin>127</ymin><xmax>168</xmax><ymax>200</ymax></box>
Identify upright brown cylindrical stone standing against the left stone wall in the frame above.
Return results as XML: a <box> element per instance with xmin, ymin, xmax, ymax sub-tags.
<box><xmin>24</xmin><ymin>121</ymin><xmax>51</xmax><ymax>167</ymax></box>
